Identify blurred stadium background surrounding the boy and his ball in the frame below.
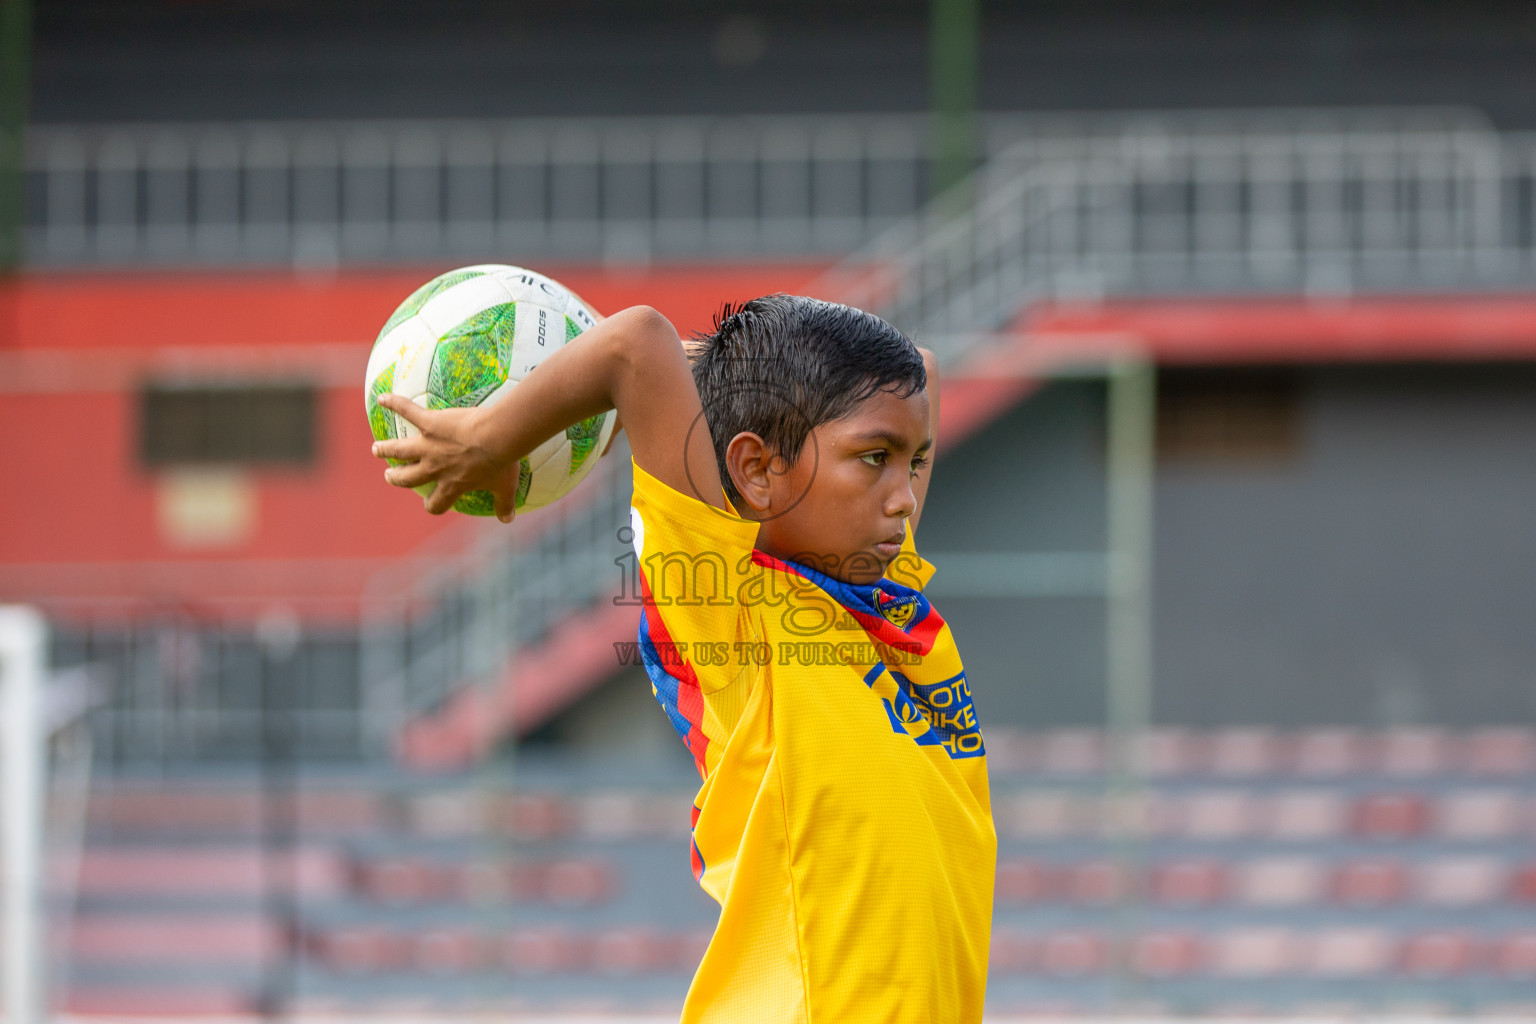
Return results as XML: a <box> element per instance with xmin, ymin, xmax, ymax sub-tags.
<box><xmin>0</xmin><ymin>0</ymin><xmax>1536</xmax><ymax>1021</ymax></box>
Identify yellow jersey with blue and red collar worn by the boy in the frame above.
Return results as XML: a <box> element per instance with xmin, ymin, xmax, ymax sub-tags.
<box><xmin>630</xmin><ymin>459</ymin><xmax>997</xmax><ymax>1024</ymax></box>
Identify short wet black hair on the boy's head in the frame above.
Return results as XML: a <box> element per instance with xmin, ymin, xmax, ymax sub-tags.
<box><xmin>690</xmin><ymin>295</ymin><xmax>928</xmax><ymax>510</ymax></box>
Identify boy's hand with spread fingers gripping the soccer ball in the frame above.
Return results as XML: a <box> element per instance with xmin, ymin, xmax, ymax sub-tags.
<box><xmin>373</xmin><ymin>395</ymin><xmax>518</xmax><ymax>522</ymax></box>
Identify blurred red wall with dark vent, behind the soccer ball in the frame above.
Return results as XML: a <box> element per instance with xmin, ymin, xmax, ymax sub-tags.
<box><xmin>0</xmin><ymin>264</ymin><xmax>822</xmax><ymax>617</ymax></box>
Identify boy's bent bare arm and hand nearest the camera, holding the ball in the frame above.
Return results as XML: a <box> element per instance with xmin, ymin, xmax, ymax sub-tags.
<box><xmin>373</xmin><ymin>306</ymin><xmax>725</xmax><ymax>522</ymax></box>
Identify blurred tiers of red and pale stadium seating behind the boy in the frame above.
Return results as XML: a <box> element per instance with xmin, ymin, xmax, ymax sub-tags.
<box><xmin>57</xmin><ymin>729</ymin><xmax>1536</xmax><ymax>1016</ymax></box>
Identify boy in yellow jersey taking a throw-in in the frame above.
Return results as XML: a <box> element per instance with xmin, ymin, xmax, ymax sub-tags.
<box><xmin>373</xmin><ymin>295</ymin><xmax>997</xmax><ymax>1024</ymax></box>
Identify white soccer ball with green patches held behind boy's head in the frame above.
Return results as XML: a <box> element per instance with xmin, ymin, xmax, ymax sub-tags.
<box><xmin>366</xmin><ymin>264</ymin><xmax>614</xmax><ymax>516</ymax></box>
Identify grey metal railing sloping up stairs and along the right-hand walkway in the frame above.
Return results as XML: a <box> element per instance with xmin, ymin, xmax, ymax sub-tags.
<box><xmin>825</xmin><ymin>119</ymin><xmax>1536</xmax><ymax>350</ymax></box>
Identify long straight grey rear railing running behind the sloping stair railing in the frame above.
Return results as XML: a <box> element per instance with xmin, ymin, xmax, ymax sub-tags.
<box><xmin>25</xmin><ymin>109</ymin><xmax>1487</xmax><ymax>267</ymax></box>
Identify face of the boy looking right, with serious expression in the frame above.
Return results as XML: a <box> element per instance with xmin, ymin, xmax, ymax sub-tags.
<box><xmin>743</xmin><ymin>391</ymin><xmax>932</xmax><ymax>583</ymax></box>
